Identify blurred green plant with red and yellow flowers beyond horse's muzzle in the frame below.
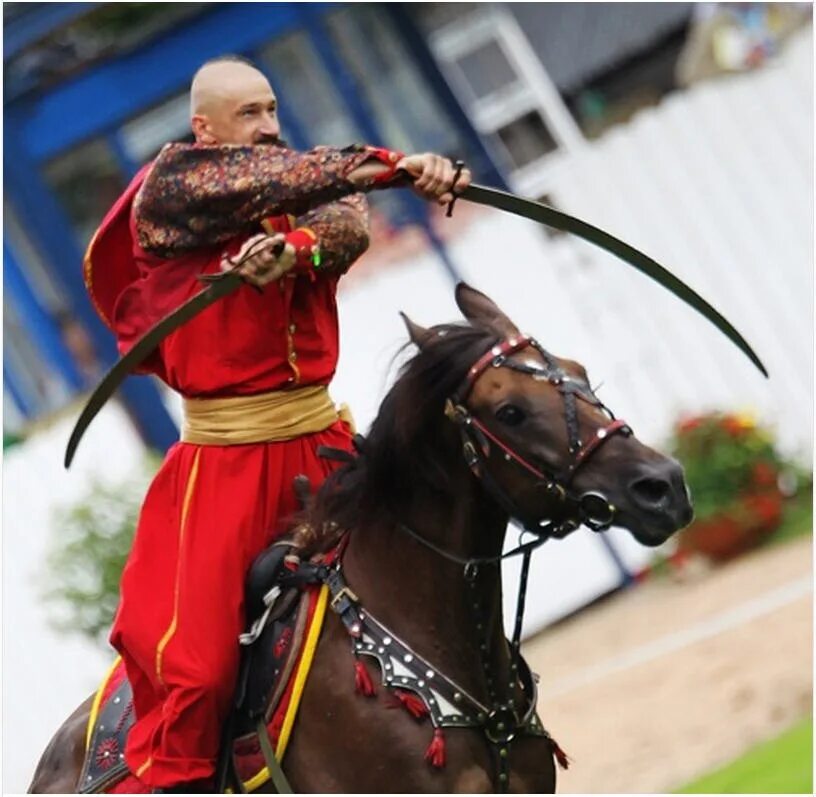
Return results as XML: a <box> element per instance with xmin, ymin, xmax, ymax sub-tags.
<box><xmin>671</xmin><ymin>412</ymin><xmax>795</xmax><ymax>521</ymax></box>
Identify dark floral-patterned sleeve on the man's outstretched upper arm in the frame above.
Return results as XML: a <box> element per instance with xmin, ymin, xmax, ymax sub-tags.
<box><xmin>133</xmin><ymin>144</ymin><xmax>382</xmax><ymax>257</ymax></box>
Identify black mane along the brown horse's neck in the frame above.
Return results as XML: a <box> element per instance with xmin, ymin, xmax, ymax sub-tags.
<box><xmin>299</xmin><ymin>324</ymin><xmax>499</xmax><ymax>552</ymax></box>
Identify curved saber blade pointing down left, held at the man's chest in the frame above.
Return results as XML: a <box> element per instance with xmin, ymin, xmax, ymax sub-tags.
<box><xmin>64</xmin><ymin>273</ymin><xmax>244</xmax><ymax>468</ymax></box>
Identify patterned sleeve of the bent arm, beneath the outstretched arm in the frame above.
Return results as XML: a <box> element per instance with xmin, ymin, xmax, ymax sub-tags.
<box><xmin>297</xmin><ymin>194</ymin><xmax>368</xmax><ymax>274</ymax></box>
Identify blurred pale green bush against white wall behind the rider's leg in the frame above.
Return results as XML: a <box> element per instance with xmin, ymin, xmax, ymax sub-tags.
<box><xmin>44</xmin><ymin>457</ymin><xmax>158</xmax><ymax>642</ymax></box>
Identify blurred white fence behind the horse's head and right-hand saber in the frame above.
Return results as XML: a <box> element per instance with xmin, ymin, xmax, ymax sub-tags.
<box><xmin>334</xmin><ymin>26</ymin><xmax>813</xmax><ymax>633</ymax></box>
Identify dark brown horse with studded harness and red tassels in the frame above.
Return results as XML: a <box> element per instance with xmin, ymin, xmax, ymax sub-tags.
<box><xmin>30</xmin><ymin>283</ymin><xmax>692</xmax><ymax>793</ymax></box>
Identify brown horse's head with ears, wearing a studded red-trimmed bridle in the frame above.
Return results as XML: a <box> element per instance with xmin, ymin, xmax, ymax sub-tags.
<box><xmin>404</xmin><ymin>283</ymin><xmax>692</xmax><ymax>546</ymax></box>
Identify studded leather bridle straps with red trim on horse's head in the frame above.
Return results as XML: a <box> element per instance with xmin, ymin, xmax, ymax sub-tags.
<box><xmin>445</xmin><ymin>335</ymin><xmax>632</xmax><ymax>536</ymax></box>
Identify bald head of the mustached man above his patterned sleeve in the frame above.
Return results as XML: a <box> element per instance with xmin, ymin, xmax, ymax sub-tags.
<box><xmin>190</xmin><ymin>59</ymin><xmax>280</xmax><ymax>145</ymax></box>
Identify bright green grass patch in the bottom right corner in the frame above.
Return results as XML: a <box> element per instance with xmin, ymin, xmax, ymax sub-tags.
<box><xmin>677</xmin><ymin>718</ymin><xmax>813</xmax><ymax>794</ymax></box>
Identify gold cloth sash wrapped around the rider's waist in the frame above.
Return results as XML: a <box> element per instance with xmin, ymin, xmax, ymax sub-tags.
<box><xmin>181</xmin><ymin>385</ymin><xmax>354</xmax><ymax>446</ymax></box>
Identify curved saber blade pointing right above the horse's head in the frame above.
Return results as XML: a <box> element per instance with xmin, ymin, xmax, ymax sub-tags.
<box><xmin>460</xmin><ymin>185</ymin><xmax>768</xmax><ymax>378</ymax></box>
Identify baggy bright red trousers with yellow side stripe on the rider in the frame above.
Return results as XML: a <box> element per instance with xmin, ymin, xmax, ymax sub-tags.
<box><xmin>111</xmin><ymin>421</ymin><xmax>351</xmax><ymax>787</ymax></box>
